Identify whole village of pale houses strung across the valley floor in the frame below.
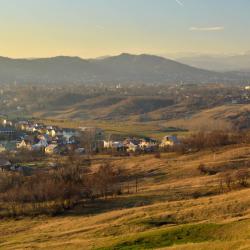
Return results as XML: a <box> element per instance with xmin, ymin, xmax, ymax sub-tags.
<box><xmin>0</xmin><ymin>119</ymin><xmax>180</xmax><ymax>171</ymax></box>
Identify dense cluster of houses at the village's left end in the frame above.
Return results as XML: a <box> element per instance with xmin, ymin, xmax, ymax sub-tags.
<box><xmin>0</xmin><ymin>120</ymin><xmax>88</xmax><ymax>154</ymax></box>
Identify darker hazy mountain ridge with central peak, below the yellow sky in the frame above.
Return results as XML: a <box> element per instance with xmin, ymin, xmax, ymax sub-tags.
<box><xmin>0</xmin><ymin>53</ymin><xmax>244</xmax><ymax>84</ymax></box>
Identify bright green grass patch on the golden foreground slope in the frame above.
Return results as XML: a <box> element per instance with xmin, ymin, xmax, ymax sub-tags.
<box><xmin>100</xmin><ymin>223</ymin><xmax>224</xmax><ymax>250</ymax></box>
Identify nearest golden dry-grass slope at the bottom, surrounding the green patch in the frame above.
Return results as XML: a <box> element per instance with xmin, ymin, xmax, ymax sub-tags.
<box><xmin>0</xmin><ymin>190</ymin><xmax>250</xmax><ymax>249</ymax></box>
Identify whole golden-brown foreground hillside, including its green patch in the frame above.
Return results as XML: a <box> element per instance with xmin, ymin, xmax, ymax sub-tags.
<box><xmin>0</xmin><ymin>146</ymin><xmax>250</xmax><ymax>250</ymax></box>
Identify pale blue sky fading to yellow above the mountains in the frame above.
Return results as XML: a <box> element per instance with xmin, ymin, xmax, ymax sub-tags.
<box><xmin>0</xmin><ymin>0</ymin><xmax>250</xmax><ymax>58</ymax></box>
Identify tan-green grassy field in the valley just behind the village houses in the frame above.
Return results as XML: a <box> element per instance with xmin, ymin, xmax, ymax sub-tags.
<box><xmin>34</xmin><ymin>104</ymin><xmax>250</xmax><ymax>139</ymax></box>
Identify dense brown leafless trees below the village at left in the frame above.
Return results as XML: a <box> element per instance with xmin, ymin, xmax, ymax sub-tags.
<box><xmin>0</xmin><ymin>160</ymin><xmax>126</xmax><ymax>215</ymax></box>
